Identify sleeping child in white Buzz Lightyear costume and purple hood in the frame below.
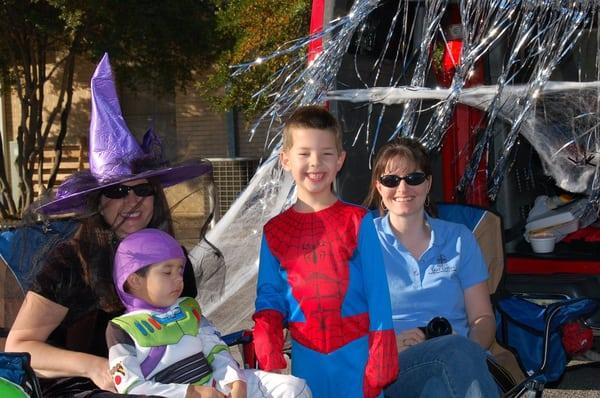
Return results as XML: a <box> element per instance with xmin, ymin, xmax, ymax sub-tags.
<box><xmin>106</xmin><ymin>229</ymin><xmax>311</xmax><ymax>398</ymax></box>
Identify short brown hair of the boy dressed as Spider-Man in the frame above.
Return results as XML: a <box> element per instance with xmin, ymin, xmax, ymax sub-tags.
<box><xmin>283</xmin><ymin>105</ymin><xmax>344</xmax><ymax>153</ymax></box>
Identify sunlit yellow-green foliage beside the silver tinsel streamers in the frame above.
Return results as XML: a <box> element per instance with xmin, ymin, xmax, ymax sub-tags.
<box><xmin>204</xmin><ymin>0</ymin><xmax>311</xmax><ymax>119</ymax></box>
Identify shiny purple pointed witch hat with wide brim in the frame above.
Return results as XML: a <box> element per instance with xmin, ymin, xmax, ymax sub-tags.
<box><xmin>38</xmin><ymin>54</ymin><xmax>212</xmax><ymax>214</ymax></box>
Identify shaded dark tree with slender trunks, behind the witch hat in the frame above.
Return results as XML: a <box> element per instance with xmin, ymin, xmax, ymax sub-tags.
<box><xmin>0</xmin><ymin>0</ymin><xmax>217</xmax><ymax>218</ymax></box>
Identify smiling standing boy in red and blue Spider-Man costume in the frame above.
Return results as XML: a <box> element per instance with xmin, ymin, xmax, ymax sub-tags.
<box><xmin>253</xmin><ymin>106</ymin><xmax>398</xmax><ymax>398</ymax></box>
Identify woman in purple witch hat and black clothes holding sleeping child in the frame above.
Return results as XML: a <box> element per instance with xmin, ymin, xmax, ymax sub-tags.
<box><xmin>6</xmin><ymin>55</ymin><xmax>211</xmax><ymax>397</ymax></box>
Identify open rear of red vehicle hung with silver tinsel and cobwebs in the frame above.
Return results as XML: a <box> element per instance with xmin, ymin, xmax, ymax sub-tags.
<box><xmin>325</xmin><ymin>0</ymin><xmax>600</xmax><ymax>336</ymax></box>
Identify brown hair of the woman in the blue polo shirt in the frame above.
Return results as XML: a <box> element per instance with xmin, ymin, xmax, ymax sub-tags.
<box><xmin>363</xmin><ymin>137</ymin><xmax>432</xmax><ymax>215</ymax></box>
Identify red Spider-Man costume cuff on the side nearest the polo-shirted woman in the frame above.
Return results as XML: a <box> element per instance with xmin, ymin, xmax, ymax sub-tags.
<box><xmin>363</xmin><ymin>330</ymin><xmax>399</xmax><ymax>398</ymax></box>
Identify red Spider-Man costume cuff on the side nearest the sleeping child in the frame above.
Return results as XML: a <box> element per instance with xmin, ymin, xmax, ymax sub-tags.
<box><xmin>252</xmin><ymin>310</ymin><xmax>287</xmax><ymax>370</ymax></box>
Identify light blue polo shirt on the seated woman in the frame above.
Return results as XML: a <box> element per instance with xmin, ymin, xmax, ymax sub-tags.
<box><xmin>375</xmin><ymin>215</ymin><xmax>488</xmax><ymax>336</ymax></box>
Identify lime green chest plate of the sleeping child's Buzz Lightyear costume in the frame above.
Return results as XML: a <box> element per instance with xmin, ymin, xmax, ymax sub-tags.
<box><xmin>111</xmin><ymin>298</ymin><xmax>201</xmax><ymax>347</ymax></box>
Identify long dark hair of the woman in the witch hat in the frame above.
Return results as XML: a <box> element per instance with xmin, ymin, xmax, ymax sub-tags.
<box><xmin>72</xmin><ymin>179</ymin><xmax>173</xmax><ymax>312</ymax></box>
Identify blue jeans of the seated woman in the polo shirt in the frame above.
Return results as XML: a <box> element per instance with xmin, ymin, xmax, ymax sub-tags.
<box><xmin>384</xmin><ymin>335</ymin><xmax>500</xmax><ymax>398</ymax></box>
